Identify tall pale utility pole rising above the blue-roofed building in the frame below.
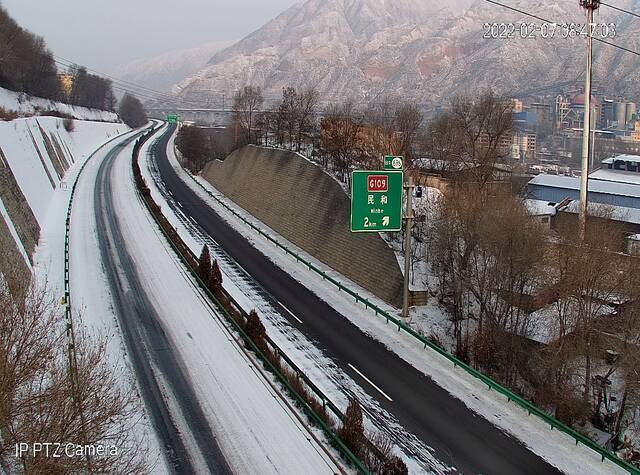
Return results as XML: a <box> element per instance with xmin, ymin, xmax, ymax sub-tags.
<box><xmin>580</xmin><ymin>0</ymin><xmax>600</xmax><ymax>242</ymax></box>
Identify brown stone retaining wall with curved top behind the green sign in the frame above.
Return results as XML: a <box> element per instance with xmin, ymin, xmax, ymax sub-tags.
<box><xmin>202</xmin><ymin>146</ymin><xmax>402</xmax><ymax>306</ymax></box>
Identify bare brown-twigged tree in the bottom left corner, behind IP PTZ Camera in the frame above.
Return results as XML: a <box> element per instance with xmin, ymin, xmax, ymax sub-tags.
<box><xmin>0</xmin><ymin>280</ymin><xmax>147</xmax><ymax>474</ymax></box>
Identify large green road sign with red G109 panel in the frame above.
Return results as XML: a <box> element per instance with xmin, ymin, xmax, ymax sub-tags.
<box><xmin>351</xmin><ymin>170</ymin><xmax>403</xmax><ymax>233</ymax></box>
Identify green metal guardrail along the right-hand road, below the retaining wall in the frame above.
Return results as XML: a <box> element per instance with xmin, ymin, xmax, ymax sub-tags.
<box><xmin>175</xmin><ymin>144</ymin><xmax>640</xmax><ymax>475</ymax></box>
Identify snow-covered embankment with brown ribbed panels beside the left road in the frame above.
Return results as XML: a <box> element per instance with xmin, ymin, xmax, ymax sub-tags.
<box><xmin>0</xmin><ymin>117</ymin><xmax>129</xmax><ymax>286</ymax></box>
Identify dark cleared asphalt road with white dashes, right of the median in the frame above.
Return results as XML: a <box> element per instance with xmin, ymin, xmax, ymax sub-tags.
<box><xmin>152</xmin><ymin>127</ymin><xmax>560</xmax><ymax>475</ymax></box>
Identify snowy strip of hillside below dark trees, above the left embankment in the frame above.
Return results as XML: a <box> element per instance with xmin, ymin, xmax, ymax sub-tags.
<box><xmin>0</xmin><ymin>87</ymin><xmax>120</xmax><ymax>122</ymax></box>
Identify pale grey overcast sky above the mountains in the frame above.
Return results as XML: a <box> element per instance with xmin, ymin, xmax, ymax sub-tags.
<box><xmin>0</xmin><ymin>0</ymin><xmax>298</xmax><ymax>72</ymax></box>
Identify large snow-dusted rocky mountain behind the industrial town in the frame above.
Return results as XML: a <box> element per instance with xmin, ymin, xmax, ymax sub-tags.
<box><xmin>173</xmin><ymin>0</ymin><xmax>640</xmax><ymax>104</ymax></box>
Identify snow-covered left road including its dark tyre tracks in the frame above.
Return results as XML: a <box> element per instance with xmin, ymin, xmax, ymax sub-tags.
<box><xmin>71</xmin><ymin>127</ymin><xmax>337</xmax><ymax>474</ymax></box>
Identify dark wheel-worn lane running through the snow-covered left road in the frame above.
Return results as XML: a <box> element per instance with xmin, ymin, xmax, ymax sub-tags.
<box><xmin>94</xmin><ymin>130</ymin><xmax>231</xmax><ymax>474</ymax></box>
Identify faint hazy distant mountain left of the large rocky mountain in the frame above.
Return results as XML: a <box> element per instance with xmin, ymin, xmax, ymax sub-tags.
<box><xmin>111</xmin><ymin>41</ymin><xmax>229</xmax><ymax>92</ymax></box>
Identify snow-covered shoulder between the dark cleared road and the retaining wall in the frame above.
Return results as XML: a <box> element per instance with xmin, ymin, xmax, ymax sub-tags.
<box><xmin>162</xmin><ymin>132</ymin><xmax>627</xmax><ymax>474</ymax></box>
